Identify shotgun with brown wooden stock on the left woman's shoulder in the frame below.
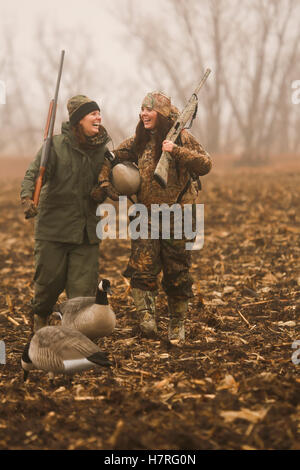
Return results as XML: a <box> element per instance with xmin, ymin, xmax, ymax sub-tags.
<box><xmin>33</xmin><ymin>51</ymin><xmax>65</xmax><ymax>207</ymax></box>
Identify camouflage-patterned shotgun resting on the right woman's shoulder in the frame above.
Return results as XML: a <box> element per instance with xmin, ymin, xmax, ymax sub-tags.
<box><xmin>154</xmin><ymin>69</ymin><xmax>211</xmax><ymax>188</ymax></box>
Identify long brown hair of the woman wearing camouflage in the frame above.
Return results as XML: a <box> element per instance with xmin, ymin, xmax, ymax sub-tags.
<box><xmin>133</xmin><ymin>113</ymin><xmax>173</xmax><ymax>161</ymax></box>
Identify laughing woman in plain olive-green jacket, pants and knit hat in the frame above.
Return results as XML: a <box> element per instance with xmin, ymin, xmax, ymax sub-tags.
<box><xmin>21</xmin><ymin>95</ymin><xmax>110</xmax><ymax>331</ymax></box>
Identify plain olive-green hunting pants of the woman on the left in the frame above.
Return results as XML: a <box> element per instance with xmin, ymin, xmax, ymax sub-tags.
<box><xmin>32</xmin><ymin>240</ymin><xmax>99</xmax><ymax>317</ymax></box>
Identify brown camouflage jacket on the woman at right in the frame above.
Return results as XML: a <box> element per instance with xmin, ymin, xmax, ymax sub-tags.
<box><xmin>99</xmin><ymin>130</ymin><xmax>212</xmax><ymax>208</ymax></box>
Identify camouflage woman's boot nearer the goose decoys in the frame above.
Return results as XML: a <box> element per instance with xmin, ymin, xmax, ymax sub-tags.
<box><xmin>131</xmin><ymin>287</ymin><xmax>157</xmax><ymax>337</ymax></box>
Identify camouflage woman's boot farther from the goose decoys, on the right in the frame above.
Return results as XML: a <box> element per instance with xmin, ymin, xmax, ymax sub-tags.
<box><xmin>168</xmin><ymin>297</ymin><xmax>188</xmax><ymax>344</ymax></box>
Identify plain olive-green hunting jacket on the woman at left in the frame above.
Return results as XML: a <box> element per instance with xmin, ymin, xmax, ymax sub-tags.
<box><xmin>21</xmin><ymin>122</ymin><xmax>110</xmax><ymax>244</ymax></box>
